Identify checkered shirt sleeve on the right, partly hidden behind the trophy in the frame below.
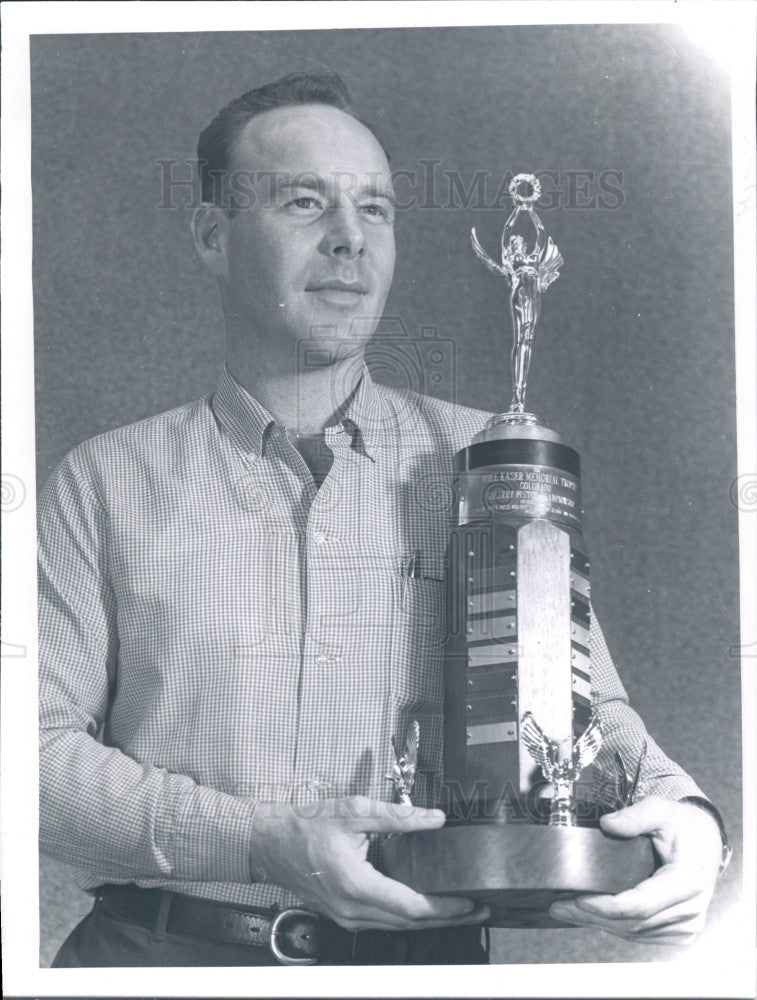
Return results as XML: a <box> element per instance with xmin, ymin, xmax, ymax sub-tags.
<box><xmin>589</xmin><ymin>614</ymin><xmax>706</xmax><ymax>808</ymax></box>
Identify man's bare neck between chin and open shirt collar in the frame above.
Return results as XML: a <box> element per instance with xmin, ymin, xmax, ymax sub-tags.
<box><xmin>226</xmin><ymin>356</ymin><xmax>362</xmax><ymax>434</ymax></box>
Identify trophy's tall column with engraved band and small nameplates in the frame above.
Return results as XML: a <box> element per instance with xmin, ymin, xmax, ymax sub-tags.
<box><xmin>445</xmin><ymin>423</ymin><xmax>591</xmax><ymax>825</ymax></box>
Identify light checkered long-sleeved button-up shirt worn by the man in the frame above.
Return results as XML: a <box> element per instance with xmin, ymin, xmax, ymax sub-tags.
<box><xmin>39</xmin><ymin>372</ymin><xmax>701</xmax><ymax>907</ymax></box>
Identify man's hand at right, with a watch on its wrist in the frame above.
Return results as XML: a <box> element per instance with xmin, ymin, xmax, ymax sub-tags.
<box><xmin>550</xmin><ymin>796</ymin><xmax>723</xmax><ymax>944</ymax></box>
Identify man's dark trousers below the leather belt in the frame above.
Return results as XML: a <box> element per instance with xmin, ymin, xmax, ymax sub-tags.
<box><xmin>52</xmin><ymin>900</ymin><xmax>489</xmax><ymax>969</ymax></box>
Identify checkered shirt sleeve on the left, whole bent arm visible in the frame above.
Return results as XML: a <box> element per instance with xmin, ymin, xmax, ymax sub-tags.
<box><xmin>38</xmin><ymin>450</ymin><xmax>262</xmax><ymax>883</ymax></box>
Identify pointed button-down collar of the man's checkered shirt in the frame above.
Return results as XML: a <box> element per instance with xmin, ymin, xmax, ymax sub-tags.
<box><xmin>212</xmin><ymin>364</ymin><xmax>395</xmax><ymax>459</ymax></box>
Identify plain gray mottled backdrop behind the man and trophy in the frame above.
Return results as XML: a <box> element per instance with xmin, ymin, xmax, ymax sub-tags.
<box><xmin>34</xmin><ymin>26</ymin><xmax>741</xmax><ymax>964</ymax></box>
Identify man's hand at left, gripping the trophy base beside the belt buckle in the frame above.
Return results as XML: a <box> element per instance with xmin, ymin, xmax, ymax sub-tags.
<box><xmin>250</xmin><ymin>796</ymin><xmax>489</xmax><ymax>931</ymax></box>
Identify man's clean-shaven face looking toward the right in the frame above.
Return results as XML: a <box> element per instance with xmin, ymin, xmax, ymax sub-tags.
<box><xmin>223</xmin><ymin>105</ymin><xmax>394</xmax><ymax>356</ymax></box>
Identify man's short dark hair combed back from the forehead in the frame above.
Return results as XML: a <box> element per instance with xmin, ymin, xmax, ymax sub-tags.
<box><xmin>197</xmin><ymin>73</ymin><xmax>358</xmax><ymax>202</ymax></box>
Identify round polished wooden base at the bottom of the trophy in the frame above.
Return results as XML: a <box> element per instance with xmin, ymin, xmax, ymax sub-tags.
<box><xmin>382</xmin><ymin>822</ymin><xmax>655</xmax><ymax>927</ymax></box>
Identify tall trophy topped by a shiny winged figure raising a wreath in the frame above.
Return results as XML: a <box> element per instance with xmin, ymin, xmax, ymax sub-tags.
<box><xmin>382</xmin><ymin>174</ymin><xmax>655</xmax><ymax>927</ymax></box>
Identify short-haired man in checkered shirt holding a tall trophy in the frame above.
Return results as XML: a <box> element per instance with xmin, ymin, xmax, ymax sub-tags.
<box><xmin>40</xmin><ymin>75</ymin><xmax>722</xmax><ymax>966</ymax></box>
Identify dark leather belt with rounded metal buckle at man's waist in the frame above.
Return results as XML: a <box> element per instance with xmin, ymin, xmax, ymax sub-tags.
<box><xmin>97</xmin><ymin>885</ymin><xmax>356</xmax><ymax>965</ymax></box>
